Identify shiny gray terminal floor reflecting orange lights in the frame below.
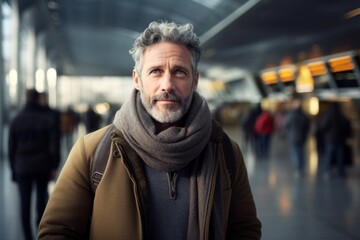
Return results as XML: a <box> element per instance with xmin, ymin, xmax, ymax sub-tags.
<box><xmin>0</xmin><ymin>126</ymin><xmax>360</xmax><ymax>240</ymax></box>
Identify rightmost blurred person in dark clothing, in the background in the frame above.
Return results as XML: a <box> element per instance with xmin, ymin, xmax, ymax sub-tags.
<box><xmin>318</xmin><ymin>102</ymin><xmax>352</xmax><ymax>179</ymax></box>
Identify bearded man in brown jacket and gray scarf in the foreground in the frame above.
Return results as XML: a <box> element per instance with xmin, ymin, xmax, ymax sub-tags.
<box><xmin>38</xmin><ymin>22</ymin><xmax>261</xmax><ymax>240</ymax></box>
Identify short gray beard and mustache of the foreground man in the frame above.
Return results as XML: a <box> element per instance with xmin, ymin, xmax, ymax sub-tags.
<box><xmin>140</xmin><ymin>89</ymin><xmax>194</xmax><ymax>123</ymax></box>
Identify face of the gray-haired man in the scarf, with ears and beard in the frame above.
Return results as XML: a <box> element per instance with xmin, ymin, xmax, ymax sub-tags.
<box><xmin>133</xmin><ymin>42</ymin><xmax>199</xmax><ymax>123</ymax></box>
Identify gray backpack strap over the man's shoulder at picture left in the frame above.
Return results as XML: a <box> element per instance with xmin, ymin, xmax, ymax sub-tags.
<box><xmin>90</xmin><ymin>124</ymin><xmax>115</xmax><ymax>193</ymax></box>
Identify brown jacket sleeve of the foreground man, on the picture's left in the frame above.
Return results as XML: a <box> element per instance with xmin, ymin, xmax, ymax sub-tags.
<box><xmin>38</xmin><ymin>138</ymin><xmax>93</xmax><ymax>240</ymax></box>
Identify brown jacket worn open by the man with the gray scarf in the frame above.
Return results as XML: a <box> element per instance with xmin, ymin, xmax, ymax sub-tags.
<box><xmin>38</xmin><ymin>127</ymin><xmax>261</xmax><ymax>240</ymax></box>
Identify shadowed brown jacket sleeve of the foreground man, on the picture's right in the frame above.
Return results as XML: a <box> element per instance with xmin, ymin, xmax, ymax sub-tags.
<box><xmin>227</xmin><ymin>141</ymin><xmax>261</xmax><ymax>240</ymax></box>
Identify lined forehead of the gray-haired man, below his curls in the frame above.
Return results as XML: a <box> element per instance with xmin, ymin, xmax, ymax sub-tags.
<box><xmin>143</xmin><ymin>42</ymin><xmax>192</xmax><ymax>67</ymax></box>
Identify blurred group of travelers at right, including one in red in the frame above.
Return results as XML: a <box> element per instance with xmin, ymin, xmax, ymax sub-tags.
<box><xmin>240</xmin><ymin>98</ymin><xmax>353</xmax><ymax>179</ymax></box>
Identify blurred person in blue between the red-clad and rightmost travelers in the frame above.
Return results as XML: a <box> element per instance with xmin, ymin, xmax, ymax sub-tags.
<box><xmin>284</xmin><ymin>99</ymin><xmax>310</xmax><ymax>177</ymax></box>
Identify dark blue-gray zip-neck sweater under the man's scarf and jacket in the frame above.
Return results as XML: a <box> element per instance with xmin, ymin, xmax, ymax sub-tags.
<box><xmin>144</xmin><ymin>164</ymin><xmax>190</xmax><ymax>240</ymax></box>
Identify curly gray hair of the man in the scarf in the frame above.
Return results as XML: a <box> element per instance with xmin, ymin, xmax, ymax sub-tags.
<box><xmin>129</xmin><ymin>22</ymin><xmax>201</xmax><ymax>74</ymax></box>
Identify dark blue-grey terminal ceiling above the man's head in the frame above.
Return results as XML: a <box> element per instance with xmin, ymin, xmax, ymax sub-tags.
<box><xmin>18</xmin><ymin>0</ymin><xmax>360</xmax><ymax>76</ymax></box>
